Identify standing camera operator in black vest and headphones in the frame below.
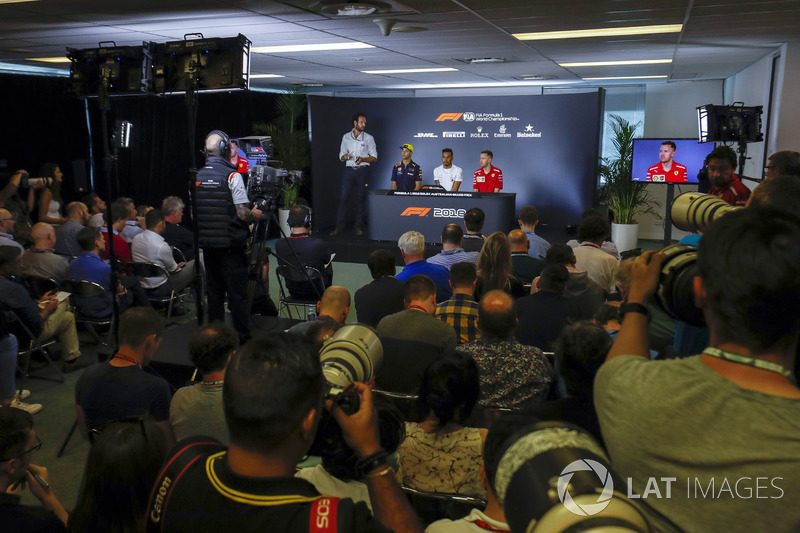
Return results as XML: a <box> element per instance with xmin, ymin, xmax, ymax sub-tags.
<box><xmin>196</xmin><ymin>130</ymin><xmax>262</xmax><ymax>341</ymax></box>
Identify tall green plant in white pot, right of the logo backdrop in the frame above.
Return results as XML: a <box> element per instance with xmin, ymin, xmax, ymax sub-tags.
<box><xmin>600</xmin><ymin>115</ymin><xmax>661</xmax><ymax>252</ymax></box>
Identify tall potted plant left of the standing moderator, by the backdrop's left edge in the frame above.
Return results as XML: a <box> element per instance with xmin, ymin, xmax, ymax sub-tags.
<box><xmin>253</xmin><ymin>91</ymin><xmax>311</xmax><ymax>233</ymax></box>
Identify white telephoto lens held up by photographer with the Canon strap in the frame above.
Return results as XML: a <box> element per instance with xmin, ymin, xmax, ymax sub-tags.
<box><xmin>319</xmin><ymin>324</ymin><xmax>383</xmax><ymax>414</ymax></box>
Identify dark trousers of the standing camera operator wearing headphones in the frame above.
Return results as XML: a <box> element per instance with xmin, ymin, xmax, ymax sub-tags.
<box><xmin>203</xmin><ymin>246</ymin><xmax>250</xmax><ymax>339</ymax></box>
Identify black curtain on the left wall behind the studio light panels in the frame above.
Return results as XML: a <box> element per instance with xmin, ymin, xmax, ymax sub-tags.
<box><xmin>0</xmin><ymin>75</ymin><xmax>275</xmax><ymax>211</ymax></box>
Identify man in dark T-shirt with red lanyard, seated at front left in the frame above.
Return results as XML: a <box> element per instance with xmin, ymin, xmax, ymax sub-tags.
<box><xmin>75</xmin><ymin>307</ymin><xmax>175</xmax><ymax>447</ymax></box>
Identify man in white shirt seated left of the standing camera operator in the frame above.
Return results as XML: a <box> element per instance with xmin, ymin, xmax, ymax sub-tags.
<box><xmin>131</xmin><ymin>209</ymin><xmax>194</xmax><ymax>297</ymax></box>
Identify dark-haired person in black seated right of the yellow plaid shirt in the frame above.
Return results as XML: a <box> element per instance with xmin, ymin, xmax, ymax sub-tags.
<box><xmin>516</xmin><ymin>263</ymin><xmax>573</xmax><ymax>351</ymax></box>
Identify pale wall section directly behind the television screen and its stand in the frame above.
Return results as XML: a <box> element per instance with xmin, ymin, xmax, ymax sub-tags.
<box><xmin>638</xmin><ymin>80</ymin><xmax>723</xmax><ymax>239</ymax></box>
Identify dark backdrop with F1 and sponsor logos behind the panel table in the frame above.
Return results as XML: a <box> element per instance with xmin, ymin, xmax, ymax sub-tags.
<box><xmin>310</xmin><ymin>91</ymin><xmax>603</xmax><ymax>235</ymax></box>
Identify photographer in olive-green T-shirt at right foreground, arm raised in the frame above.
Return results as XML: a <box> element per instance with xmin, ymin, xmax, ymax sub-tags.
<box><xmin>594</xmin><ymin>208</ymin><xmax>800</xmax><ymax>532</ymax></box>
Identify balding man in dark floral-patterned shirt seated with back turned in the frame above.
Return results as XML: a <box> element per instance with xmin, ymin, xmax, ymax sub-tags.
<box><xmin>456</xmin><ymin>291</ymin><xmax>553</xmax><ymax>409</ymax></box>
